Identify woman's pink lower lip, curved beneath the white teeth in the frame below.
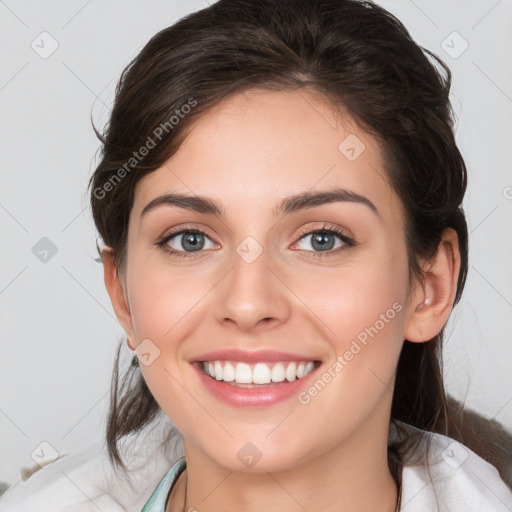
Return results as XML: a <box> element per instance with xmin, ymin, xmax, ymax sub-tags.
<box><xmin>192</xmin><ymin>362</ymin><xmax>320</xmax><ymax>407</ymax></box>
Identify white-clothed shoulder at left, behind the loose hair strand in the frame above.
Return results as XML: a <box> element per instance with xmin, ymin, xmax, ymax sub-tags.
<box><xmin>0</xmin><ymin>418</ymin><xmax>182</xmax><ymax>512</ymax></box>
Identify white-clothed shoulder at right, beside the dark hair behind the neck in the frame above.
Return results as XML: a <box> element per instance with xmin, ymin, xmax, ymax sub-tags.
<box><xmin>400</xmin><ymin>427</ymin><xmax>512</xmax><ymax>512</ymax></box>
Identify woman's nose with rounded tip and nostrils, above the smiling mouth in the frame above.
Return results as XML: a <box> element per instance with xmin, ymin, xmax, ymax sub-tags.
<box><xmin>215</xmin><ymin>242</ymin><xmax>290</xmax><ymax>332</ymax></box>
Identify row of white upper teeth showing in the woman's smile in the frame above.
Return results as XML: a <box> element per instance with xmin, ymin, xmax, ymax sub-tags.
<box><xmin>203</xmin><ymin>361</ymin><xmax>315</xmax><ymax>384</ymax></box>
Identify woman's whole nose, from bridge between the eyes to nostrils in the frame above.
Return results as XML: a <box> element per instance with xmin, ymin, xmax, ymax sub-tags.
<box><xmin>215</xmin><ymin>237</ymin><xmax>288</xmax><ymax>330</ymax></box>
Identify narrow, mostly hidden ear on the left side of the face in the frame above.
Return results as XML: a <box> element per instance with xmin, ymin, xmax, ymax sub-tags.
<box><xmin>101</xmin><ymin>247</ymin><xmax>135</xmax><ymax>350</ymax></box>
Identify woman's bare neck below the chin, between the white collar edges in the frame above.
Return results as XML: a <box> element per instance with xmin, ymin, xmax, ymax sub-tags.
<box><xmin>166</xmin><ymin>418</ymin><xmax>397</xmax><ymax>512</ymax></box>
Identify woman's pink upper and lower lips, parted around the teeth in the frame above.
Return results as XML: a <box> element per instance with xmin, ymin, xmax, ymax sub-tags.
<box><xmin>190</xmin><ymin>349</ymin><xmax>319</xmax><ymax>407</ymax></box>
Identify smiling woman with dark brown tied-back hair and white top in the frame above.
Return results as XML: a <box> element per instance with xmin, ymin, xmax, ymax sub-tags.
<box><xmin>2</xmin><ymin>0</ymin><xmax>512</xmax><ymax>512</ymax></box>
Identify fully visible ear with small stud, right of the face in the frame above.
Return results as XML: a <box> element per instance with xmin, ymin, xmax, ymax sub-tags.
<box><xmin>404</xmin><ymin>228</ymin><xmax>460</xmax><ymax>343</ymax></box>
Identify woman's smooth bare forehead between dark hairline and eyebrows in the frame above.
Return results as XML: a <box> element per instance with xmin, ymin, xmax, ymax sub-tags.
<box><xmin>134</xmin><ymin>89</ymin><xmax>397</xmax><ymax>224</ymax></box>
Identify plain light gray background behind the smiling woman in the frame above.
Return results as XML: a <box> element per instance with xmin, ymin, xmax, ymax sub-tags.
<box><xmin>0</xmin><ymin>0</ymin><xmax>512</xmax><ymax>484</ymax></box>
